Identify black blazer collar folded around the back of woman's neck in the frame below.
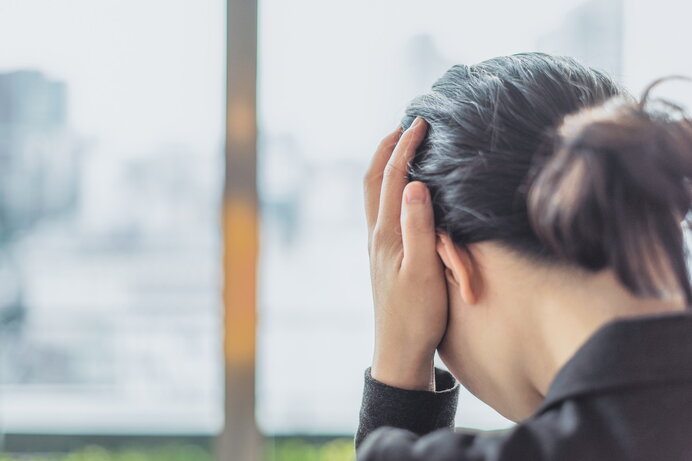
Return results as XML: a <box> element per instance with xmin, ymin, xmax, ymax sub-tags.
<box><xmin>536</xmin><ymin>309</ymin><xmax>692</xmax><ymax>414</ymax></box>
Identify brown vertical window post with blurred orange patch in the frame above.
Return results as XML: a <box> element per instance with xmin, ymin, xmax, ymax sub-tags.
<box><xmin>217</xmin><ymin>0</ymin><xmax>262</xmax><ymax>461</ymax></box>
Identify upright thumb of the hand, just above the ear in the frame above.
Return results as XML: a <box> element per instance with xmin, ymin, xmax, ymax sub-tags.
<box><xmin>401</xmin><ymin>181</ymin><xmax>437</xmax><ymax>267</ymax></box>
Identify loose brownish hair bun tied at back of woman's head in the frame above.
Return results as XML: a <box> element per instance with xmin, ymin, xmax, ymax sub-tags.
<box><xmin>528</xmin><ymin>80</ymin><xmax>692</xmax><ymax>299</ymax></box>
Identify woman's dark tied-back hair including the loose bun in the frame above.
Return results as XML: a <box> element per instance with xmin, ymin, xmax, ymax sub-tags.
<box><xmin>402</xmin><ymin>53</ymin><xmax>692</xmax><ymax>305</ymax></box>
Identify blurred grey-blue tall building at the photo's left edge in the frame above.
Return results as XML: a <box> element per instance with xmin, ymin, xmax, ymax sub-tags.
<box><xmin>0</xmin><ymin>70</ymin><xmax>79</xmax><ymax>237</ymax></box>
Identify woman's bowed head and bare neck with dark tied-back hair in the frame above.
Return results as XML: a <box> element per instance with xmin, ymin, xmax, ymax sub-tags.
<box><xmin>403</xmin><ymin>53</ymin><xmax>692</xmax><ymax>419</ymax></box>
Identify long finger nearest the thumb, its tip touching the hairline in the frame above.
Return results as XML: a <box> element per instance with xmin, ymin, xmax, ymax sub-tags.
<box><xmin>377</xmin><ymin>117</ymin><xmax>428</xmax><ymax>229</ymax></box>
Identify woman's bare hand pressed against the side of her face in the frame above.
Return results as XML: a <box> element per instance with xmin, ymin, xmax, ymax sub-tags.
<box><xmin>364</xmin><ymin>117</ymin><xmax>447</xmax><ymax>390</ymax></box>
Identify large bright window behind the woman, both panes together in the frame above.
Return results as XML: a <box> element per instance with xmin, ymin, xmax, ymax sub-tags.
<box><xmin>5</xmin><ymin>0</ymin><xmax>692</xmax><ymax>449</ymax></box>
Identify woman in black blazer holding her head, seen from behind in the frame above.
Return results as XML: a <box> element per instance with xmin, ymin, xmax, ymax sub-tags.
<box><xmin>355</xmin><ymin>53</ymin><xmax>692</xmax><ymax>461</ymax></box>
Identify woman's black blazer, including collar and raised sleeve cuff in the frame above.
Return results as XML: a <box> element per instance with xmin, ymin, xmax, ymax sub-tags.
<box><xmin>355</xmin><ymin>311</ymin><xmax>692</xmax><ymax>461</ymax></box>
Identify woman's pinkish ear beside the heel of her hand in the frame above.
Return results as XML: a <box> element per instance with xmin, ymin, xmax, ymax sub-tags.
<box><xmin>436</xmin><ymin>233</ymin><xmax>480</xmax><ymax>304</ymax></box>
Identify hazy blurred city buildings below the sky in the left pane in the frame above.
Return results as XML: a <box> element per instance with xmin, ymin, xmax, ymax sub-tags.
<box><xmin>0</xmin><ymin>70</ymin><xmax>221</xmax><ymax>432</ymax></box>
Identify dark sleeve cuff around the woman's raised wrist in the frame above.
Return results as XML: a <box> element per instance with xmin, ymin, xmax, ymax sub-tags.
<box><xmin>356</xmin><ymin>367</ymin><xmax>460</xmax><ymax>444</ymax></box>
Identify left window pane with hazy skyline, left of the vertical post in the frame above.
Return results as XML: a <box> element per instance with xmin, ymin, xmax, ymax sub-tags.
<box><xmin>0</xmin><ymin>0</ymin><xmax>225</xmax><ymax>433</ymax></box>
